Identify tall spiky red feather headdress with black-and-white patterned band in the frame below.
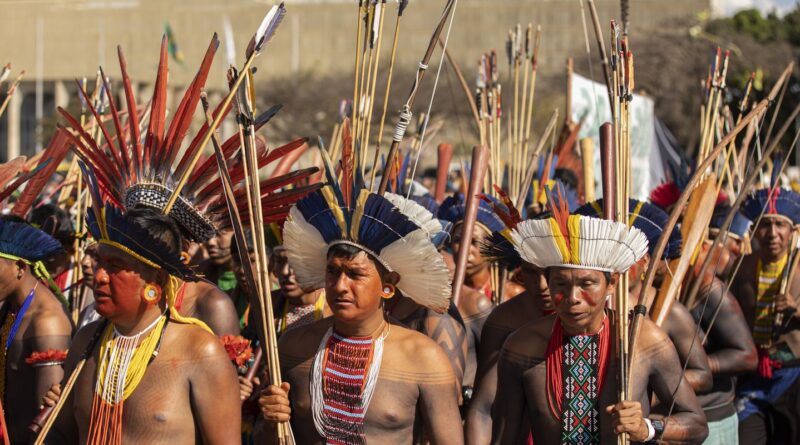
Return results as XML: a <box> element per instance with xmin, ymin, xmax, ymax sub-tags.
<box><xmin>59</xmin><ymin>34</ymin><xmax>316</xmax><ymax>242</ymax></box>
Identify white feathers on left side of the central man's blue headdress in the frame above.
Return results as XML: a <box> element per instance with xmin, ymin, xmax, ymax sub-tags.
<box><xmin>283</xmin><ymin>207</ymin><xmax>328</xmax><ymax>289</ymax></box>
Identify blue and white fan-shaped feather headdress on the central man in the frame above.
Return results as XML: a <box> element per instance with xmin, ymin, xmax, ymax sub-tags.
<box><xmin>283</xmin><ymin>148</ymin><xmax>451</xmax><ymax>312</ymax></box>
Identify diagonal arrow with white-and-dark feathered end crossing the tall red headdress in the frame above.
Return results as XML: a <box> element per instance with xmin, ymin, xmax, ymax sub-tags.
<box><xmin>162</xmin><ymin>3</ymin><xmax>286</xmax><ymax>215</ymax></box>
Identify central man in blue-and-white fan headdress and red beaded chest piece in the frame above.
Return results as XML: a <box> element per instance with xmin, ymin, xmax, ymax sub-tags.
<box><xmin>259</xmin><ymin>183</ymin><xmax>463</xmax><ymax>444</ymax></box>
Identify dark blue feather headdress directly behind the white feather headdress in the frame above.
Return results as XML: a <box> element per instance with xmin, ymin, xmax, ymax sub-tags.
<box><xmin>575</xmin><ymin>198</ymin><xmax>683</xmax><ymax>260</ymax></box>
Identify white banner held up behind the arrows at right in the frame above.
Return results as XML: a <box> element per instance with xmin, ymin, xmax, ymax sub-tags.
<box><xmin>572</xmin><ymin>74</ymin><xmax>664</xmax><ymax>200</ymax></box>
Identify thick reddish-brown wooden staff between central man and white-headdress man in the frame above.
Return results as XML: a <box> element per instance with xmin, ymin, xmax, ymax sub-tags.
<box><xmin>453</xmin><ymin>145</ymin><xmax>489</xmax><ymax>307</ymax></box>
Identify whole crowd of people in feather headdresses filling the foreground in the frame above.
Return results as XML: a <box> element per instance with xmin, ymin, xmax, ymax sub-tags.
<box><xmin>0</xmin><ymin>3</ymin><xmax>800</xmax><ymax>445</ymax></box>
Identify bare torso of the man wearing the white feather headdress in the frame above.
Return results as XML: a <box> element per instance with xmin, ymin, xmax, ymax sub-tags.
<box><xmin>492</xmin><ymin>315</ymin><xmax>706</xmax><ymax>444</ymax></box>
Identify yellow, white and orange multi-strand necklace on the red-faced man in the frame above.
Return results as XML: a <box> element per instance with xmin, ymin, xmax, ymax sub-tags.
<box><xmin>87</xmin><ymin>314</ymin><xmax>169</xmax><ymax>445</ymax></box>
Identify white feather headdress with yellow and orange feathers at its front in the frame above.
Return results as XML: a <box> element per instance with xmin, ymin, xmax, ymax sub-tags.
<box><xmin>511</xmin><ymin>193</ymin><xmax>647</xmax><ymax>272</ymax></box>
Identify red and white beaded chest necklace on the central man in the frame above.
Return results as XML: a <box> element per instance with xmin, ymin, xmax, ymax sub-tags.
<box><xmin>310</xmin><ymin>324</ymin><xmax>389</xmax><ymax>445</ymax></box>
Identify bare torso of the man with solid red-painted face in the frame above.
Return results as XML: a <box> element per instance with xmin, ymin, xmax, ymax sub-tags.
<box><xmin>51</xmin><ymin>322</ymin><xmax>241</xmax><ymax>445</ymax></box>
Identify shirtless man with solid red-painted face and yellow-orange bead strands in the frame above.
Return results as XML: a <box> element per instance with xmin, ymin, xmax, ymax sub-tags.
<box><xmin>48</xmin><ymin>207</ymin><xmax>240</xmax><ymax>444</ymax></box>
